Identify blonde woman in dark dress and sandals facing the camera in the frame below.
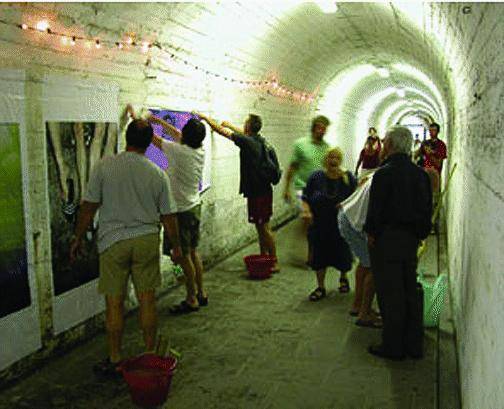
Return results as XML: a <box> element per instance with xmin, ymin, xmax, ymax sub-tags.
<box><xmin>303</xmin><ymin>148</ymin><xmax>357</xmax><ymax>301</ymax></box>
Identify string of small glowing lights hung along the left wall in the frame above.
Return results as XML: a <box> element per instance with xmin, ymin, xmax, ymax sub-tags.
<box><xmin>0</xmin><ymin>19</ymin><xmax>315</xmax><ymax>103</ymax></box>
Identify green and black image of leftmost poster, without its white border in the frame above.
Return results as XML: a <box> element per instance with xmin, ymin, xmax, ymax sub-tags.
<box><xmin>0</xmin><ymin>123</ymin><xmax>31</xmax><ymax>318</ymax></box>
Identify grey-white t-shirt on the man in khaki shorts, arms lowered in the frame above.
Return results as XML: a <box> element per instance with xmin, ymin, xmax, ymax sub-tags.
<box><xmin>83</xmin><ymin>152</ymin><xmax>177</xmax><ymax>253</ymax></box>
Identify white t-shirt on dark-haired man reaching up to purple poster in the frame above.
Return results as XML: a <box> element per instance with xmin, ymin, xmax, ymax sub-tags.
<box><xmin>162</xmin><ymin>139</ymin><xmax>205</xmax><ymax>212</ymax></box>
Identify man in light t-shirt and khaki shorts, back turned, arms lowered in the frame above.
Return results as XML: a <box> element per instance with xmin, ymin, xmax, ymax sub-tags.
<box><xmin>70</xmin><ymin>120</ymin><xmax>182</xmax><ymax>376</ymax></box>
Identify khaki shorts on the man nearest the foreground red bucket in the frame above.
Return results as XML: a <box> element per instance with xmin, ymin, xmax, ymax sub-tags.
<box><xmin>98</xmin><ymin>233</ymin><xmax>161</xmax><ymax>296</ymax></box>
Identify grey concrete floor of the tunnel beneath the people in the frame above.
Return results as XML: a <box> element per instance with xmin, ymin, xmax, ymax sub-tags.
<box><xmin>0</xmin><ymin>222</ymin><xmax>456</xmax><ymax>409</ymax></box>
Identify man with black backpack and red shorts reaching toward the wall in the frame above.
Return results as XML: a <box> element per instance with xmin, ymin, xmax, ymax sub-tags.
<box><xmin>197</xmin><ymin>113</ymin><xmax>282</xmax><ymax>272</ymax></box>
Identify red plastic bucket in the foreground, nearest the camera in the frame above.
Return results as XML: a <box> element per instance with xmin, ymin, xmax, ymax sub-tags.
<box><xmin>122</xmin><ymin>354</ymin><xmax>177</xmax><ymax>408</ymax></box>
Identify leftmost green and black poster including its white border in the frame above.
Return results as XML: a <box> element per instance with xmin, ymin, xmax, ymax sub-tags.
<box><xmin>0</xmin><ymin>70</ymin><xmax>41</xmax><ymax>370</ymax></box>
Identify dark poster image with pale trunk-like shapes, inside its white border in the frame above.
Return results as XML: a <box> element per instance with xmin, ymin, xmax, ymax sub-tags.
<box><xmin>46</xmin><ymin>121</ymin><xmax>118</xmax><ymax>296</ymax></box>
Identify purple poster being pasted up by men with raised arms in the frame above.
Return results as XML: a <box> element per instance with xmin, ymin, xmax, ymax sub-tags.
<box><xmin>145</xmin><ymin>109</ymin><xmax>211</xmax><ymax>192</ymax></box>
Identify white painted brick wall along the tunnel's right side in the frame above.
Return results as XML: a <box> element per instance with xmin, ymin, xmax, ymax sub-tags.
<box><xmin>432</xmin><ymin>3</ymin><xmax>504</xmax><ymax>409</ymax></box>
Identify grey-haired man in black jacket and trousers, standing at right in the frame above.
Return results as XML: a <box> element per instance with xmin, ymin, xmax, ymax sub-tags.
<box><xmin>364</xmin><ymin>126</ymin><xmax>432</xmax><ymax>359</ymax></box>
